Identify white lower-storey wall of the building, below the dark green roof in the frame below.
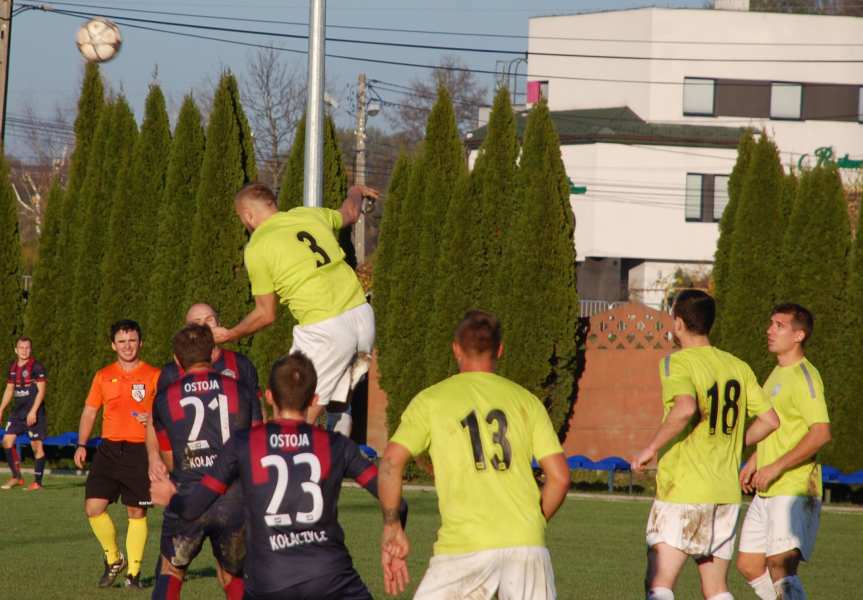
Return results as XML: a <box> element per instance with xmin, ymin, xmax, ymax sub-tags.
<box><xmin>561</xmin><ymin>144</ymin><xmax>736</xmax><ymax>262</ymax></box>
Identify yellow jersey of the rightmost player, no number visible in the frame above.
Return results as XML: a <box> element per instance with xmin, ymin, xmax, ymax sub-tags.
<box><xmin>757</xmin><ymin>358</ymin><xmax>830</xmax><ymax>498</ymax></box>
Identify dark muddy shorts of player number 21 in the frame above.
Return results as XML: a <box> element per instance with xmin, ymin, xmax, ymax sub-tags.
<box><xmin>160</xmin><ymin>485</ymin><xmax>246</xmax><ymax>577</ymax></box>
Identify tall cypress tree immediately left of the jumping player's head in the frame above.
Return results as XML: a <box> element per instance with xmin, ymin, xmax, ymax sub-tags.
<box><xmin>186</xmin><ymin>72</ymin><xmax>258</xmax><ymax>346</ymax></box>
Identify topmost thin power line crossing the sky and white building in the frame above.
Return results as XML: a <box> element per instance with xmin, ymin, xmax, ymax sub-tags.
<box><xmin>30</xmin><ymin>2</ymin><xmax>863</xmax><ymax>48</ymax></box>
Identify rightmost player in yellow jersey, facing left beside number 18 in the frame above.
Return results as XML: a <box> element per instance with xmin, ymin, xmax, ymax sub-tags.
<box><xmin>737</xmin><ymin>304</ymin><xmax>830</xmax><ymax>600</ymax></box>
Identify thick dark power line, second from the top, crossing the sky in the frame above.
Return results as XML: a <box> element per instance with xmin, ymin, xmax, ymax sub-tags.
<box><xmin>22</xmin><ymin>4</ymin><xmax>863</xmax><ymax>64</ymax></box>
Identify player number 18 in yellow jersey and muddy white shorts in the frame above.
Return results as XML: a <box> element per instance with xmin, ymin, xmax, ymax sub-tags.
<box><xmin>632</xmin><ymin>290</ymin><xmax>779</xmax><ymax>600</ymax></box>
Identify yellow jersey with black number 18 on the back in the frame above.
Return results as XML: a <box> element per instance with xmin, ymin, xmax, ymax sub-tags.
<box><xmin>656</xmin><ymin>346</ymin><xmax>770</xmax><ymax>504</ymax></box>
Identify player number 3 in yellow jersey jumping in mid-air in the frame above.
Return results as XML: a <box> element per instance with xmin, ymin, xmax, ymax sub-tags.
<box><xmin>213</xmin><ymin>183</ymin><xmax>378</xmax><ymax>435</ymax></box>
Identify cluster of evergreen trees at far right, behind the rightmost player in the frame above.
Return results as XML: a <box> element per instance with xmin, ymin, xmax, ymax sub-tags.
<box><xmin>711</xmin><ymin>132</ymin><xmax>863</xmax><ymax>469</ymax></box>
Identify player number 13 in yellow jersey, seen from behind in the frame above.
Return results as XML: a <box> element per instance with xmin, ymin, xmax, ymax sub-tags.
<box><xmin>378</xmin><ymin>310</ymin><xmax>570</xmax><ymax>600</ymax></box>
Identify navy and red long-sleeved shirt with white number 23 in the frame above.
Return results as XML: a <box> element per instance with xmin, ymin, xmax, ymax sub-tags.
<box><xmin>169</xmin><ymin>419</ymin><xmax>394</xmax><ymax>594</ymax></box>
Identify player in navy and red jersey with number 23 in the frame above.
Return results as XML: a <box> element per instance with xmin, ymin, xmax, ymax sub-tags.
<box><xmin>151</xmin><ymin>352</ymin><xmax>407</xmax><ymax>600</ymax></box>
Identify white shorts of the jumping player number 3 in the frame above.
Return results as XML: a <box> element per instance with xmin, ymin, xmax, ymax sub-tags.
<box><xmin>291</xmin><ymin>304</ymin><xmax>375</xmax><ymax>405</ymax></box>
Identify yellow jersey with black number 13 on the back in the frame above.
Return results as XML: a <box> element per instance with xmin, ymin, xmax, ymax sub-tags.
<box><xmin>391</xmin><ymin>372</ymin><xmax>563</xmax><ymax>555</ymax></box>
